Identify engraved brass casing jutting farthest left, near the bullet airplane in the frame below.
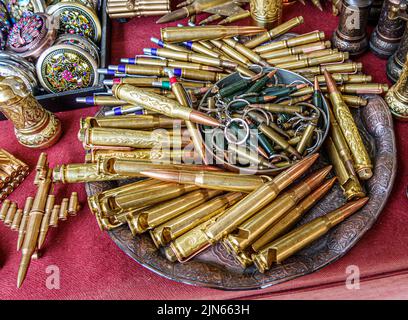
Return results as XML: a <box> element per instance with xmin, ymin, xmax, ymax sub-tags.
<box><xmin>53</xmin><ymin>163</ymin><xmax>129</xmax><ymax>183</ymax></box>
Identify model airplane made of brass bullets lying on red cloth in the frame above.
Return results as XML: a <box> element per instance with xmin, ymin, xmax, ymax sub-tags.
<box><xmin>0</xmin><ymin>153</ymin><xmax>80</xmax><ymax>287</ymax></box>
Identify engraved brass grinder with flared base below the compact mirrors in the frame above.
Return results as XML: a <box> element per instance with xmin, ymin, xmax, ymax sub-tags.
<box><xmin>0</xmin><ymin>76</ymin><xmax>62</xmax><ymax>148</ymax></box>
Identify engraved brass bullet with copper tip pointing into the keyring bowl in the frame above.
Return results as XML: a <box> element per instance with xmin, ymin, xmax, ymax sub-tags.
<box><xmin>112</xmin><ymin>84</ymin><xmax>219</xmax><ymax>126</ymax></box>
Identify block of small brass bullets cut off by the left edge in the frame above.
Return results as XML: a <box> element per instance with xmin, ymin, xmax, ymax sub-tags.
<box><xmin>0</xmin><ymin>149</ymin><xmax>30</xmax><ymax>201</ymax></box>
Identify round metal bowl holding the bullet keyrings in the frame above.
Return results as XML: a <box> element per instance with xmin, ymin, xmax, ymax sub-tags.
<box><xmin>199</xmin><ymin>67</ymin><xmax>330</xmax><ymax>174</ymax></box>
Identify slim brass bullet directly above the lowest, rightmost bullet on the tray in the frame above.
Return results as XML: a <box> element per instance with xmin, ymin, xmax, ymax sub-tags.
<box><xmin>251</xmin><ymin>178</ymin><xmax>336</xmax><ymax>252</ymax></box>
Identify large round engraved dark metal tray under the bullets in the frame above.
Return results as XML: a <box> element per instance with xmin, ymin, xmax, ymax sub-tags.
<box><xmin>86</xmin><ymin>96</ymin><xmax>396</xmax><ymax>290</ymax></box>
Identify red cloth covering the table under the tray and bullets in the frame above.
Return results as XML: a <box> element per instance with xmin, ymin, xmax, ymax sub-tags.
<box><xmin>0</xmin><ymin>4</ymin><xmax>408</xmax><ymax>299</ymax></box>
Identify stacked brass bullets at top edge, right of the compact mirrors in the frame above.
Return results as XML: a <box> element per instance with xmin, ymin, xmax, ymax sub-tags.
<box><xmin>106</xmin><ymin>0</ymin><xmax>170</xmax><ymax>19</ymax></box>
